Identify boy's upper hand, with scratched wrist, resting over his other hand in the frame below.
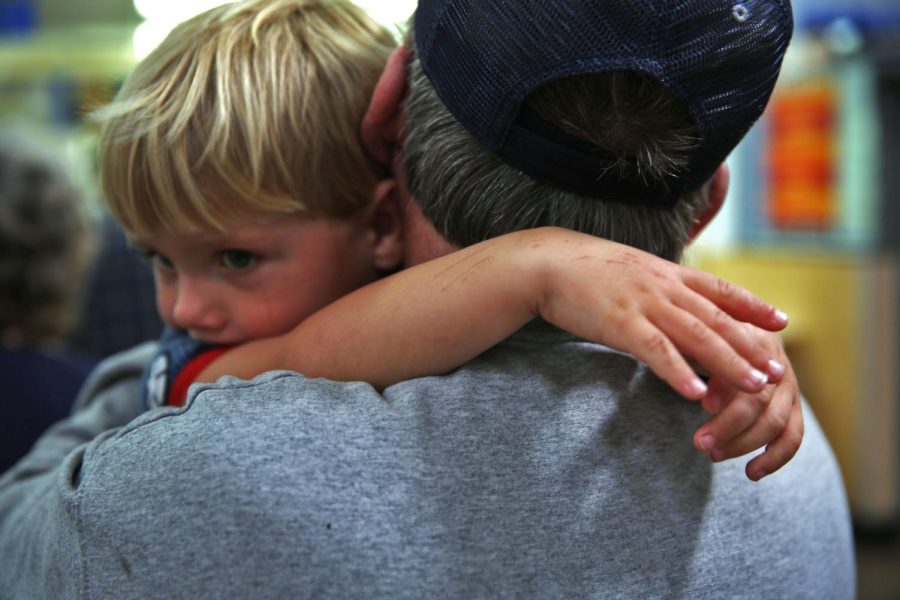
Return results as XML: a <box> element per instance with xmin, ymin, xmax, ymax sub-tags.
<box><xmin>532</xmin><ymin>230</ymin><xmax>787</xmax><ymax>400</ymax></box>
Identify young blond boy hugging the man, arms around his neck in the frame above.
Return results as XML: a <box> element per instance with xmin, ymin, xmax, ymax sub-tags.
<box><xmin>98</xmin><ymin>0</ymin><xmax>797</xmax><ymax>473</ymax></box>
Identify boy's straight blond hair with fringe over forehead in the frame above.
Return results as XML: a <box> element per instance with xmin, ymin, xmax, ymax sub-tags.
<box><xmin>96</xmin><ymin>0</ymin><xmax>395</xmax><ymax>235</ymax></box>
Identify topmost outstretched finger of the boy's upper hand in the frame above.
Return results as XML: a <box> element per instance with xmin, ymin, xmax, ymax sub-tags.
<box><xmin>682</xmin><ymin>268</ymin><xmax>788</xmax><ymax>331</ymax></box>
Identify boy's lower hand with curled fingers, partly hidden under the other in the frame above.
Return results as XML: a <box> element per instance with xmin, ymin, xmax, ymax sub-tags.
<box><xmin>694</xmin><ymin>334</ymin><xmax>803</xmax><ymax>481</ymax></box>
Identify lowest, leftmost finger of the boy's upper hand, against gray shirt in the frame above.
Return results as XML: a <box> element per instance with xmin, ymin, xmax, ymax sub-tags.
<box><xmin>622</xmin><ymin>320</ymin><xmax>707</xmax><ymax>400</ymax></box>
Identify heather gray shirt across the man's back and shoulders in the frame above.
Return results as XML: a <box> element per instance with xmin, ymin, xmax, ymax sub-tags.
<box><xmin>0</xmin><ymin>325</ymin><xmax>855</xmax><ymax>600</ymax></box>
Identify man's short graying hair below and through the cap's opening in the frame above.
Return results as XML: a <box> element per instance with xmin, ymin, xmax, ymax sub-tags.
<box><xmin>403</xmin><ymin>39</ymin><xmax>708</xmax><ymax>260</ymax></box>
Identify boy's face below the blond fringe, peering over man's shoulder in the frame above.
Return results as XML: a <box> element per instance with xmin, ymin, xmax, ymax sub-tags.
<box><xmin>133</xmin><ymin>216</ymin><xmax>378</xmax><ymax>344</ymax></box>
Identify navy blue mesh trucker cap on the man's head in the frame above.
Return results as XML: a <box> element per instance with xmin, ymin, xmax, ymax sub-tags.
<box><xmin>415</xmin><ymin>0</ymin><xmax>793</xmax><ymax>207</ymax></box>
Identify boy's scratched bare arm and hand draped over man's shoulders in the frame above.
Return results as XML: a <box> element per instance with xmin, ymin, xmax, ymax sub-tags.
<box><xmin>199</xmin><ymin>228</ymin><xmax>799</xmax><ymax>478</ymax></box>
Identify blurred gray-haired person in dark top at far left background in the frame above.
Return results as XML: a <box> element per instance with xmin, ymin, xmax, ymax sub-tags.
<box><xmin>0</xmin><ymin>131</ymin><xmax>93</xmax><ymax>471</ymax></box>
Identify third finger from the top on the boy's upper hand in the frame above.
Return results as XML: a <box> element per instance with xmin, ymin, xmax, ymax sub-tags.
<box><xmin>652</xmin><ymin>306</ymin><xmax>769</xmax><ymax>392</ymax></box>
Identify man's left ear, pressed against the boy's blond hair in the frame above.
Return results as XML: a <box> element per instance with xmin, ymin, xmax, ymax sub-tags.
<box><xmin>360</xmin><ymin>46</ymin><xmax>409</xmax><ymax>169</ymax></box>
